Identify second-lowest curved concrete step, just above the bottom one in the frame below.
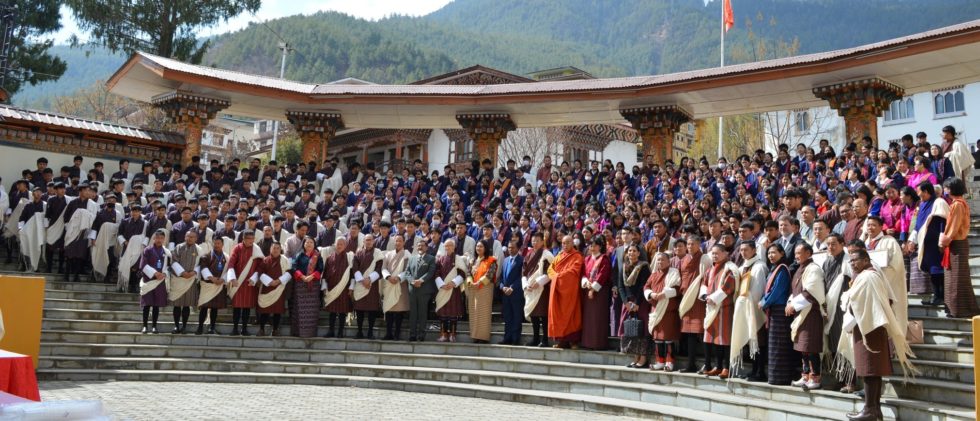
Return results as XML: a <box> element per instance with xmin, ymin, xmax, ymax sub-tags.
<box><xmin>42</xmin><ymin>354</ymin><xmax>861</xmax><ymax>419</ymax></box>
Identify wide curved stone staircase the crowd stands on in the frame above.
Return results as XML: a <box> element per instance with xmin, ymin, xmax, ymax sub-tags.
<box><xmin>13</xmin><ymin>207</ymin><xmax>980</xmax><ymax>421</ymax></box>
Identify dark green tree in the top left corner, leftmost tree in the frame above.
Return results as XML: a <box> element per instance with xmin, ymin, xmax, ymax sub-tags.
<box><xmin>3</xmin><ymin>0</ymin><xmax>67</xmax><ymax>95</ymax></box>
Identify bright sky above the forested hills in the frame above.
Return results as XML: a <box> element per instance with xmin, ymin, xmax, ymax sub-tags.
<box><xmin>53</xmin><ymin>0</ymin><xmax>452</xmax><ymax>43</ymax></box>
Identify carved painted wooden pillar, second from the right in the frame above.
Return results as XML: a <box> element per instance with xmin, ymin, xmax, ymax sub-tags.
<box><xmin>619</xmin><ymin>105</ymin><xmax>691</xmax><ymax>165</ymax></box>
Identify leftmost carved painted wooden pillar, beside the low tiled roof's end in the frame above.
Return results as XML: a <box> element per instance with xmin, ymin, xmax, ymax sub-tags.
<box><xmin>150</xmin><ymin>91</ymin><xmax>230</xmax><ymax>167</ymax></box>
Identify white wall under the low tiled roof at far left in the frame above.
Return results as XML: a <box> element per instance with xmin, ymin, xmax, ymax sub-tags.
<box><xmin>0</xmin><ymin>144</ymin><xmax>126</xmax><ymax>189</ymax></box>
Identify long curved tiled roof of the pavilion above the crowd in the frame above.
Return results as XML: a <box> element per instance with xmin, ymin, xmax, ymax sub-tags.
<box><xmin>128</xmin><ymin>20</ymin><xmax>980</xmax><ymax>96</ymax></box>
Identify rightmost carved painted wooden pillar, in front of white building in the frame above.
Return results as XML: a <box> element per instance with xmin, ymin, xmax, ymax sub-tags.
<box><xmin>813</xmin><ymin>77</ymin><xmax>905</xmax><ymax>148</ymax></box>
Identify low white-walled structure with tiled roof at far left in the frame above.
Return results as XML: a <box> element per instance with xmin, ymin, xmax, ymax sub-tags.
<box><xmin>0</xmin><ymin>104</ymin><xmax>184</xmax><ymax>187</ymax></box>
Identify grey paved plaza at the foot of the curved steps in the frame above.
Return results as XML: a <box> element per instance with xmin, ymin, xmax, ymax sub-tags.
<box><xmin>40</xmin><ymin>381</ymin><xmax>627</xmax><ymax>421</ymax></box>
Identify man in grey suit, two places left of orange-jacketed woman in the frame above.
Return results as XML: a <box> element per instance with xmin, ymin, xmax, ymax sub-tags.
<box><xmin>401</xmin><ymin>241</ymin><xmax>436</xmax><ymax>342</ymax></box>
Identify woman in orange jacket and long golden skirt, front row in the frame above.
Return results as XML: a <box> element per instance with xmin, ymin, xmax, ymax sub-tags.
<box><xmin>466</xmin><ymin>240</ymin><xmax>497</xmax><ymax>344</ymax></box>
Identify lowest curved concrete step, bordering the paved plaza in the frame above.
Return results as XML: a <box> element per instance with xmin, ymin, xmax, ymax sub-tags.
<box><xmin>38</xmin><ymin>370</ymin><xmax>748</xmax><ymax>421</ymax></box>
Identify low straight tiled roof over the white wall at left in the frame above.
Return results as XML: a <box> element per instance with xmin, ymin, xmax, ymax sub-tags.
<box><xmin>0</xmin><ymin>104</ymin><xmax>184</xmax><ymax>145</ymax></box>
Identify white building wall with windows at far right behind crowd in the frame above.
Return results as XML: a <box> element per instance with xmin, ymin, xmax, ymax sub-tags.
<box><xmin>878</xmin><ymin>83</ymin><xmax>980</xmax><ymax>149</ymax></box>
